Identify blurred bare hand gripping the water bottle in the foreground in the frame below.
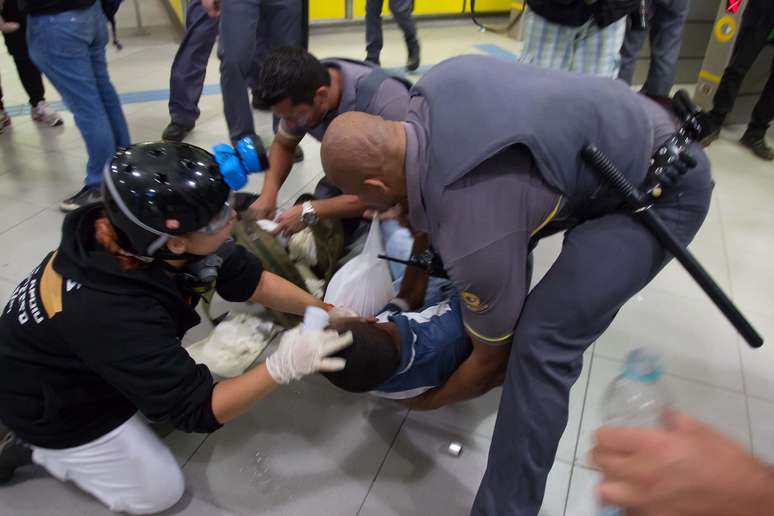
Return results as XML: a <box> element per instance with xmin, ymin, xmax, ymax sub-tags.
<box><xmin>592</xmin><ymin>413</ymin><xmax>774</xmax><ymax>516</ymax></box>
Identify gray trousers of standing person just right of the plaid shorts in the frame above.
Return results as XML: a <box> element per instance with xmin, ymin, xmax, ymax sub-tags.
<box><xmin>618</xmin><ymin>0</ymin><xmax>689</xmax><ymax>97</ymax></box>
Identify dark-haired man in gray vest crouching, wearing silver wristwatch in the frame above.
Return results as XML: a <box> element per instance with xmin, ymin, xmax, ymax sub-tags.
<box><xmin>252</xmin><ymin>48</ymin><xmax>416</xmax><ymax>239</ymax></box>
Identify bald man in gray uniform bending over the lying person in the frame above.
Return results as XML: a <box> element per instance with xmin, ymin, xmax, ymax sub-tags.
<box><xmin>321</xmin><ymin>56</ymin><xmax>712</xmax><ymax>516</ymax></box>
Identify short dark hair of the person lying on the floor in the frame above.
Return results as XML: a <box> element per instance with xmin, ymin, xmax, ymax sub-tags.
<box><xmin>323</xmin><ymin>319</ymin><xmax>400</xmax><ymax>392</ymax></box>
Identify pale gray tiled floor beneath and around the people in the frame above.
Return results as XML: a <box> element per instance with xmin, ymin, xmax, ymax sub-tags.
<box><xmin>0</xmin><ymin>8</ymin><xmax>774</xmax><ymax>516</ymax></box>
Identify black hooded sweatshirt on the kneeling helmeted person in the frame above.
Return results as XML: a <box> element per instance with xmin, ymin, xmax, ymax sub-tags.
<box><xmin>0</xmin><ymin>205</ymin><xmax>263</xmax><ymax>449</ymax></box>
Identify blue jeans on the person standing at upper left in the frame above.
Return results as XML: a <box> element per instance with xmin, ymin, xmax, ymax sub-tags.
<box><xmin>27</xmin><ymin>2</ymin><xmax>130</xmax><ymax>187</ymax></box>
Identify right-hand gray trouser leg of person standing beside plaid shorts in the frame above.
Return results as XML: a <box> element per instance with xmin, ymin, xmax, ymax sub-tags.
<box><xmin>642</xmin><ymin>0</ymin><xmax>689</xmax><ymax>98</ymax></box>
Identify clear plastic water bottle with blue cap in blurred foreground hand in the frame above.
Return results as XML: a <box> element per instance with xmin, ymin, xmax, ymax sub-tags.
<box><xmin>599</xmin><ymin>349</ymin><xmax>670</xmax><ymax>516</ymax></box>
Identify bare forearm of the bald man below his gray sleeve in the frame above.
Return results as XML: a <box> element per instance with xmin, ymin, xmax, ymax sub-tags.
<box><xmin>403</xmin><ymin>337</ymin><xmax>511</xmax><ymax>410</ymax></box>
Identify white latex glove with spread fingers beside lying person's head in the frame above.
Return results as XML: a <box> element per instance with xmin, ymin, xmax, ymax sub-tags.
<box><xmin>266</xmin><ymin>325</ymin><xmax>352</xmax><ymax>384</ymax></box>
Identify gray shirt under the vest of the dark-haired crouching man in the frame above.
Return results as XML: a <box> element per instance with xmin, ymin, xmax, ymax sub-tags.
<box><xmin>279</xmin><ymin>59</ymin><xmax>409</xmax><ymax>141</ymax></box>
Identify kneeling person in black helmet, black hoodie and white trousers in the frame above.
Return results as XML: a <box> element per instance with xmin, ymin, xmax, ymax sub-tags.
<box><xmin>0</xmin><ymin>143</ymin><xmax>354</xmax><ymax>514</ymax></box>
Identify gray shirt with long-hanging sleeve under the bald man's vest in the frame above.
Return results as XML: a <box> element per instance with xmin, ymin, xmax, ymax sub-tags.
<box><xmin>405</xmin><ymin>97</ymin><xmax>562</xmax><ymax>345</ymax></box>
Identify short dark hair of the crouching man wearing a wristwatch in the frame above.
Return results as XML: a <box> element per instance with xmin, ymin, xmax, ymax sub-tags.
<box><xmin>257</xmin><ymin>48</ymin><xmax>331</xmax><ymax>106</ymax></box>
